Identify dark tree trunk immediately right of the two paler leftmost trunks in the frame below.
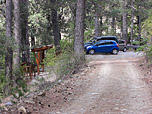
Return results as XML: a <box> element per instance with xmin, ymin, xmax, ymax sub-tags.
<box><xmin>20</xmin><ymin>0</ymin><xmax>30</xmax><ymax>63</ymax></box>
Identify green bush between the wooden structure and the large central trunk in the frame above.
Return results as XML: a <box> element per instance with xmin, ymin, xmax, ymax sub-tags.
<box><xmin>44</xmin><ymin>41</ymin><xmax>84</xmax><ymax>79</ymax></box>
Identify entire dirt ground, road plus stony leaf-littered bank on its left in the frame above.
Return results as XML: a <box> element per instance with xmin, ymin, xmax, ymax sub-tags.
<box><xmin>0</xmin><ymin>52</ymin><xmax>152</xmax><ymax>114</ymax></box>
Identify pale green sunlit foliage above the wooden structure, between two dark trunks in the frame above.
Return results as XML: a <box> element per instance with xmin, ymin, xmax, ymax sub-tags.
<box><xmin>28</xmin><ymin>1</ymin><xmax>53</xmax><ymax>48</ymax></box>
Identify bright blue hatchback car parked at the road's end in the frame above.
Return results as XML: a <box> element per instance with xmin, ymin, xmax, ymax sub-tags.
<box><xmin>85</xmin><ymin>40</ymin><xmax>119</xmax><ymax>55</ymax></box>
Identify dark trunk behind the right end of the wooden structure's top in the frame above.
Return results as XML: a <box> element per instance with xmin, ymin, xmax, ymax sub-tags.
<box><xmin>52</xmin><ymin>9</ymin><xmax>61</xmax><ymax>51</ymax></box>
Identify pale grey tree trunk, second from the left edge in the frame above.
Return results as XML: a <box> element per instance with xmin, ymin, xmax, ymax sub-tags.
<box><xmin>13</xmin><ymin>0</ymin><xmax>21</xmax><ymax>71</ymax></box>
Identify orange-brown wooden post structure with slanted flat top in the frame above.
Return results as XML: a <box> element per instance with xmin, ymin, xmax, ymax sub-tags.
<box><xmin>31</xmin><ymin>45</ymin><xmax>53</xmax><ymax>75</ymax></box>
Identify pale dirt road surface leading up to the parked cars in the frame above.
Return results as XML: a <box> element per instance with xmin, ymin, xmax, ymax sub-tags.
<box><xmin>47</xmin><ymin>52</ymin><xmax>152</xmax><ymax>114</ymax></box>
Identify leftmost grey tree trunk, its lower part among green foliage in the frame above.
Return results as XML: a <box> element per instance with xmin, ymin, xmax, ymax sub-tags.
<box><xmin>4</xmin><ymin>0</ymin><xmax>13</xmax><ymax>95</ymax></box>
